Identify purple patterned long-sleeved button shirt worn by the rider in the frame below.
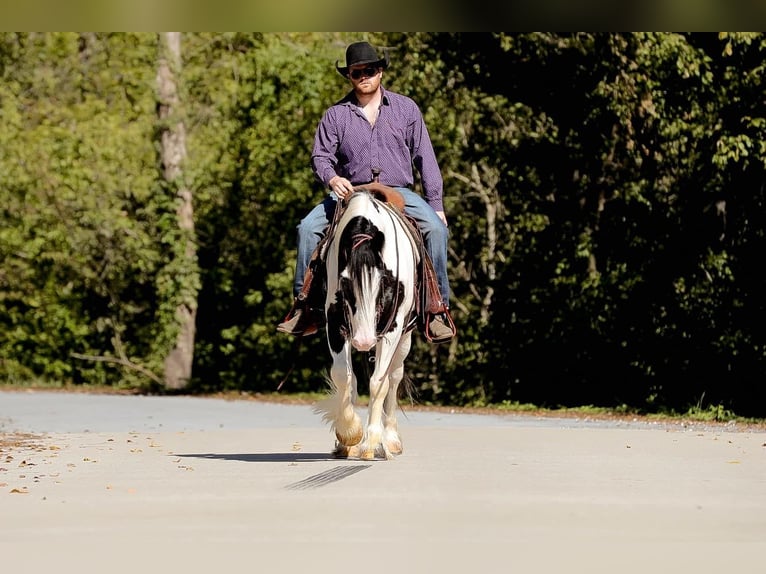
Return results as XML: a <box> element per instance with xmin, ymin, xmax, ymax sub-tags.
<box><xmin>311</xmin><ymin>86</ymin><xmax>444</xmax><ymax>211</ymax></box>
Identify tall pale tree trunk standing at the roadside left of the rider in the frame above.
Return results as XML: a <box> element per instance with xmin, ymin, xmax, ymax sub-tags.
<box><xmin>157</xmin><ymin>32</ymin><xmax>198</xmax><ymax>389</ymax></box>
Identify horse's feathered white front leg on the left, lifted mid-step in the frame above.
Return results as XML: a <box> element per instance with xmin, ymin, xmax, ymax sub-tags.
<box><xmin>314</xmin><ymin>343</ymin><xmax>364</xmax><ymax>457</ymax></box>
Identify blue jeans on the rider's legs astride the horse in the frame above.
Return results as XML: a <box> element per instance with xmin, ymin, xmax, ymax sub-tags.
<box><xmin>293</xmin><ymin>187</ymin><xmax>449</xmax><ymax>306</ymax></box>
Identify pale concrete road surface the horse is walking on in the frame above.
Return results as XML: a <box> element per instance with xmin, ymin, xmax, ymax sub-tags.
<box><xmin>0</xmin><ymin>391</ymin><xmax>766</xmax><ymax>574</ymax></box>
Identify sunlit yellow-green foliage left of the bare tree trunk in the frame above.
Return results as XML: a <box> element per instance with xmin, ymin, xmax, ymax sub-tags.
<box><xmin>0</xmin><ymin>34</ymin><xmax>158</xmax><ymax>388</ymax></box>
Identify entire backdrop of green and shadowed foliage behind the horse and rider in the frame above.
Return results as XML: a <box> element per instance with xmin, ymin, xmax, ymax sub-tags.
<box><xmin>0</xmin><ymin>33</ymin><xmax>766</xmax><ymax>418</ymax></box>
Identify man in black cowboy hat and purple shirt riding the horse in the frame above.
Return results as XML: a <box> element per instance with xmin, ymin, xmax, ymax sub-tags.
<box><xmin>277</xmin><ymin>42</ymin><xmax>455</xmax><ymax>343</ymax></box>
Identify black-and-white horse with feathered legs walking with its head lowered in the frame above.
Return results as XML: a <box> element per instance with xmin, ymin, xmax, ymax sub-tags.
<box><xmin>314</xmin><ymin>187</ymin><xmax>420</xmax><ymax>460</ymax></box>
